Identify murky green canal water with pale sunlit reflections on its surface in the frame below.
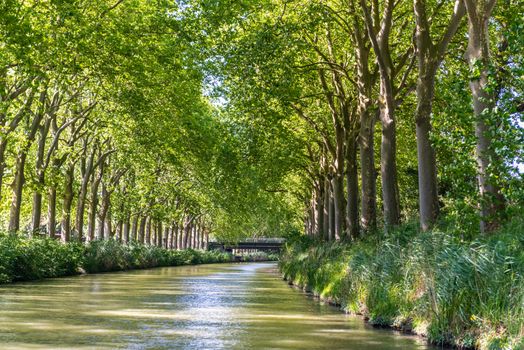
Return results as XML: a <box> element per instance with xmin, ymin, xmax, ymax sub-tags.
<box><xmin>0</xmin><ymin>263</ymin><xmax>434</xmax><ymax>349</ymax></box>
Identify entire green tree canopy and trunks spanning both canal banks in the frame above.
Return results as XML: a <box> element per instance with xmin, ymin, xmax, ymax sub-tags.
<box><xmin>0</xmin><ymin>0</ymin><xmax>523</xmax><ymax>248</ymax></box>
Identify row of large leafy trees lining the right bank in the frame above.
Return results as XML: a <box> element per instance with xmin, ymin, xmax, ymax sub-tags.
<box><xmin>186</xmin><ymin>0</ymin><xmax>523</xmax><ymax>239</ymax></box>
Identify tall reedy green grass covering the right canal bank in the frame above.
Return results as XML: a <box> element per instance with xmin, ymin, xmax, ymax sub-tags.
<box><xmin>280</xmin><ymin>218</ymin><xmax>524</xmax><ymax>349</ymax></box>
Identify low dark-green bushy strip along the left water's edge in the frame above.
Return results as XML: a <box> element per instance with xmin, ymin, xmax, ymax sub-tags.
<box><xmin>0</xmin><ymin>234</ymin><xmax>276</xmax><ymax>284</ymax></box>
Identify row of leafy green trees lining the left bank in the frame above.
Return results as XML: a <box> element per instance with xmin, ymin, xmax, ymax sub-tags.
<box><xmin>0</xmin><ymin>0</ymin><xmax>256</xmax><ymax>248</ymax></box>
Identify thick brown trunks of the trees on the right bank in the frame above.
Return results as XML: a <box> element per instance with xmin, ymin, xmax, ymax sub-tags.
<box><xmin>293</xmin><ymin>0</ymin><xmax>504</xmax><ymax>239</ymax></box>
